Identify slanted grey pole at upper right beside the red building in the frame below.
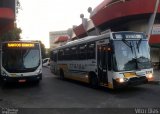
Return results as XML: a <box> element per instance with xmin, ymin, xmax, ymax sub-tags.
<box><xmin>147</xmin><ymin>0</ymin><xmax>160</xmax><ymax>41</ymax></box>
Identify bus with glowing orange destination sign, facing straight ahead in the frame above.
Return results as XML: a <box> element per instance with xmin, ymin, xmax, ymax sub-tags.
<box><xmin>1</xmin><ymin>41</ymin><xmax>42</xmax><ymax>83</ymax></box>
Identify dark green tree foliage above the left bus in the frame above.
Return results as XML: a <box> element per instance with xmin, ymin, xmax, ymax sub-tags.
<box><xmin>0</xmin><ymin>27</ymin><xmax>22</xmax><ymax>41</ymax></box>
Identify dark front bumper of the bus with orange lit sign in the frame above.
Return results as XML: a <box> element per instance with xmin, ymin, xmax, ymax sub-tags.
<box><xmin>2</xmin><ymin>74</ymin><xmax>42</xmax><ymax>82</ymax></box>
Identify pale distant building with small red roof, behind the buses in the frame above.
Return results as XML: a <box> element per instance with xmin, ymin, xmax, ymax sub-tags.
<box><xmin>49</xmin><ymin>31</ymin><xmax>69</xmax><ymax>49</ymax></box>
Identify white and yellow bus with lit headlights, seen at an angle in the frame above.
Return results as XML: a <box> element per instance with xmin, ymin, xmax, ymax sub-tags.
<box><xmin>50</xmin><ymin>31</ymin><xmax>153</xmax><ymax>89</ymax></box>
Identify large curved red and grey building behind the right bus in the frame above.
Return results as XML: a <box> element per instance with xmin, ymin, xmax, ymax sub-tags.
<box><xmin>69</xmin><ymin>0</ymin><xmax>160</xmax><ymax>66</ymax></box>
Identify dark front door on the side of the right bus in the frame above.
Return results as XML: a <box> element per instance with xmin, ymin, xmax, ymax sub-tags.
<box><xmin>97</xmin><ymin>45</ymin><xmax>108</xmax><ymax>84</ymax></box>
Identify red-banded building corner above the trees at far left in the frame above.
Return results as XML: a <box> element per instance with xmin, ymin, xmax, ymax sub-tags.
<box><xmin>0</xmin><ymin>0</ymin><xmax>16</xmax><ymax>35</ymax></box>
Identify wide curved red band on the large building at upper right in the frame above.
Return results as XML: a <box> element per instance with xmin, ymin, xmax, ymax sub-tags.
<box><xmin>91</xmin><ymin>0</ymin><xmax>160</xmax><ymax>26</ymax></box>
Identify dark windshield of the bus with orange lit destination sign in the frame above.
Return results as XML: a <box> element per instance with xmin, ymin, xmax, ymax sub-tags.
<box><xmin>2</xmin><ymin>43</ymin><xmax>40</xmax><ymax>73</ymax></box>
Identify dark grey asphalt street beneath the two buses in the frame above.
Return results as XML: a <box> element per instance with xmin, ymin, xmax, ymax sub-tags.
<box><xmin>0</xmin><ymin>67</ymin><xmax>160</xmax><ymax>108</ymax></box>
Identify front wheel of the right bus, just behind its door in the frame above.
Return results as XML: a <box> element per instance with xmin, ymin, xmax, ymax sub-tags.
<box><xmin>89</xmin><ymin>73</ymin><xmax>99</xmax><ymax>89</ymax></box>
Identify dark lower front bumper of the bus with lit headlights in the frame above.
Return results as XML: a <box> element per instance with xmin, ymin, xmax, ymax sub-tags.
<box><xmin>113</xmin><ymin>76</ymin><xmax>148</xmax><ymax>88</ymax></box>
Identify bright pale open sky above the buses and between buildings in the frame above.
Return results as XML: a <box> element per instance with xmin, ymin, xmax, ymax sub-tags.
<box><xmin>16</xmin><ymin>0</ymin><xmax>103</xmax><ymax>48</ymax></box>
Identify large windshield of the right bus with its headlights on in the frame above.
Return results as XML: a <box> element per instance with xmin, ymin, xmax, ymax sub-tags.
<box><xmin>113</xmin><ymin>40</ymin><xmax>152</xmax><ymax>71</ymax></box>
